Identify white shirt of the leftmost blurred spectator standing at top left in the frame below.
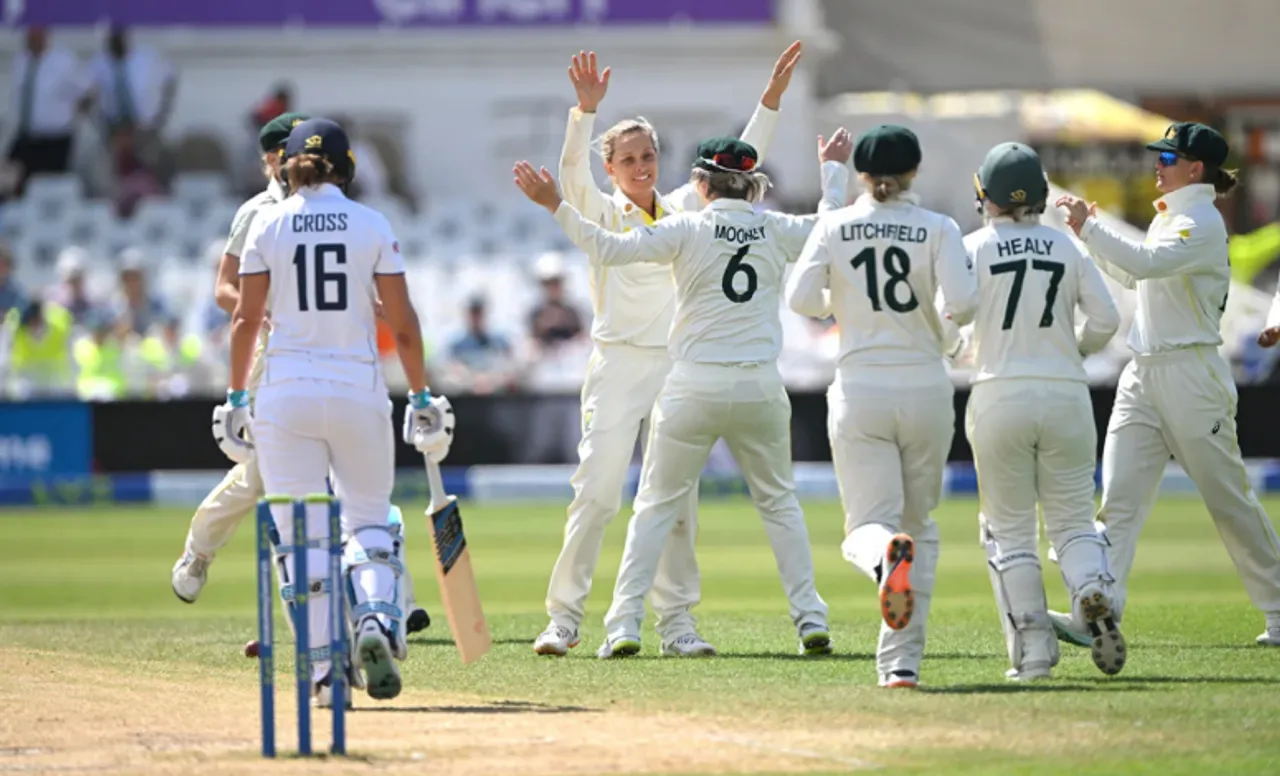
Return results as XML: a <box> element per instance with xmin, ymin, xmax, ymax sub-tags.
<box><xmin>8</xmin><ymin>46</ymin><xmax>91</xmax><ymax>136</ymax></box>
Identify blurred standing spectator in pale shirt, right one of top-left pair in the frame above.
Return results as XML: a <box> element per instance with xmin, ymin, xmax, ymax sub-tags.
<box><xmin>91</xmin><ymin>27</ymin><xmax>178</xmax><ymax>178</ymax></box>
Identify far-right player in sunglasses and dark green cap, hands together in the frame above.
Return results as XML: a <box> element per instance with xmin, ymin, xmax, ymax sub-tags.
<box><xmin>1057</xmin><ymin>122</ymin><xmax>1280</xmax><ymax>647</ymax></box>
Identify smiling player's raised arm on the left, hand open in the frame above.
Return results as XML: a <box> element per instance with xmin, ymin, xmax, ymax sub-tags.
<box><xmin>559</xmin><ymin>51</ymin><xmax>613</xmax><ymax>223</ymax></box>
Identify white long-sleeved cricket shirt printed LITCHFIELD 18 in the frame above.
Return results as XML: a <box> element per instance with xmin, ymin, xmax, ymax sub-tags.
<box><xmin>787</xmin><ymin>193</ymin><xmax>978</xmax><ymax>371</ymax></box>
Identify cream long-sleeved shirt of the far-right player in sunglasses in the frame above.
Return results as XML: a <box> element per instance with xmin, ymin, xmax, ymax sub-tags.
<box><xmin>1080</xmin><ymin>183</ymin><xmax>1231</xmax><ymax>355</ymax></box>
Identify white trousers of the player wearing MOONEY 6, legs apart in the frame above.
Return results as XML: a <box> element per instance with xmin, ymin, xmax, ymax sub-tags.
<box><xmin>604</xmin><ymin>361</ymin><xmax>827</xmax><ymax>639</ymax></box>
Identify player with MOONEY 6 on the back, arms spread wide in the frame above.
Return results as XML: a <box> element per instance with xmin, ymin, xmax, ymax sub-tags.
<box><xmin>515</xmin><ymin>129</ymin><xmax>851</xmax><ymax>658</ymax></box>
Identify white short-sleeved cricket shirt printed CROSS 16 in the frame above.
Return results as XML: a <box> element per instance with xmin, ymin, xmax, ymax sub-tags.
<box><xmin>241</xmin><ymin>183</ymin><xmax>404</xmax><ymax>391</ymax></box>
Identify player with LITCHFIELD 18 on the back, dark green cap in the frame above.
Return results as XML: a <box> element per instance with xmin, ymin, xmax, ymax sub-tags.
<box><xmin>786</xmin><ymin>124</ymin><xmax>978</xmax><ymax>688</ymax></box>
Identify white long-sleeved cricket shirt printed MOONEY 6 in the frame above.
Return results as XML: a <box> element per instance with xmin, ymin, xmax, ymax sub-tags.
<box><xmin>556</xmin><ymin>161</ymin><xmax>849</xmax><ymax>364</ymax></box>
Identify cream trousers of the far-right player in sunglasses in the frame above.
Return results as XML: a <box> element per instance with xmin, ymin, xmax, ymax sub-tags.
<box><xmin>1098</xmin><ymin>346</ymin><xmax>1280</xmax><ymax>624</ymax></box>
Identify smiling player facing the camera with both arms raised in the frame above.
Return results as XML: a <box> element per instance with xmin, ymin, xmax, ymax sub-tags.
<box><xmin>534</xmin><ymin>42</ymin><xmax>800</xmax><ymax>656</ymax></box>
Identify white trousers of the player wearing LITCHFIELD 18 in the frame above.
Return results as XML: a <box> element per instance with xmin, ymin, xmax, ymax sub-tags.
<box><xmin>827</xmin><ymin>359</ymin><xmax>955</xmax><ymax>679</ymax></box>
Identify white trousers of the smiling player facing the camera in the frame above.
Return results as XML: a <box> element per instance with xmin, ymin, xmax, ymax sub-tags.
<box><xmin>547</xmin><ymin>343</ymin><xmax>701</xmax><ymax>640</ymax></box>
